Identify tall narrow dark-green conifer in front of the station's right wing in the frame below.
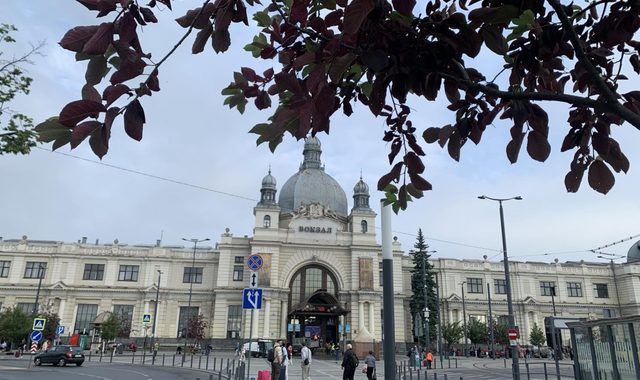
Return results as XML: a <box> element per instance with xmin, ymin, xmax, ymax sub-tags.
<box><xmin>409</xmin><ymin>229</ymin><xmax>439</xmax><ymax>345</ymax></box>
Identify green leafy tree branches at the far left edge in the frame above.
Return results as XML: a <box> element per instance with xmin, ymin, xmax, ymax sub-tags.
<box><xmin>0</xmin><ymin>24</ymin><xmax>43</xmax><ymax>155</ymax></box>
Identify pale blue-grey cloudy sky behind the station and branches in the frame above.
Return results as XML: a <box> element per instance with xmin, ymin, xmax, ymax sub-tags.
<box><xmin>0</xmin><ymin>0</ymin><xmax>640</xmax><ymax>262</ymax></box>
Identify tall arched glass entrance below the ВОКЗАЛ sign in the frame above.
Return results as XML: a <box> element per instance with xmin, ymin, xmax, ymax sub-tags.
<box><xmin>287</xmin><ymin>264</ymin><xmax>348</xmax><ymax>349</ymax></box>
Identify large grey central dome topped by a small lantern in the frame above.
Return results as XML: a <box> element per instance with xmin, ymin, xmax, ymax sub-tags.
<box><xmin>278</xmin><ymin>137</ymin><xmax>347</xmax><ymax>217</ymax></box>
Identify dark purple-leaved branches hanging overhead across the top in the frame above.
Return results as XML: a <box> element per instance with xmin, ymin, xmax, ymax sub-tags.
<box><xmin>39</xmin><ymin>0</ymin><xmax>640</xmax><ymax>211</ymax></box>
